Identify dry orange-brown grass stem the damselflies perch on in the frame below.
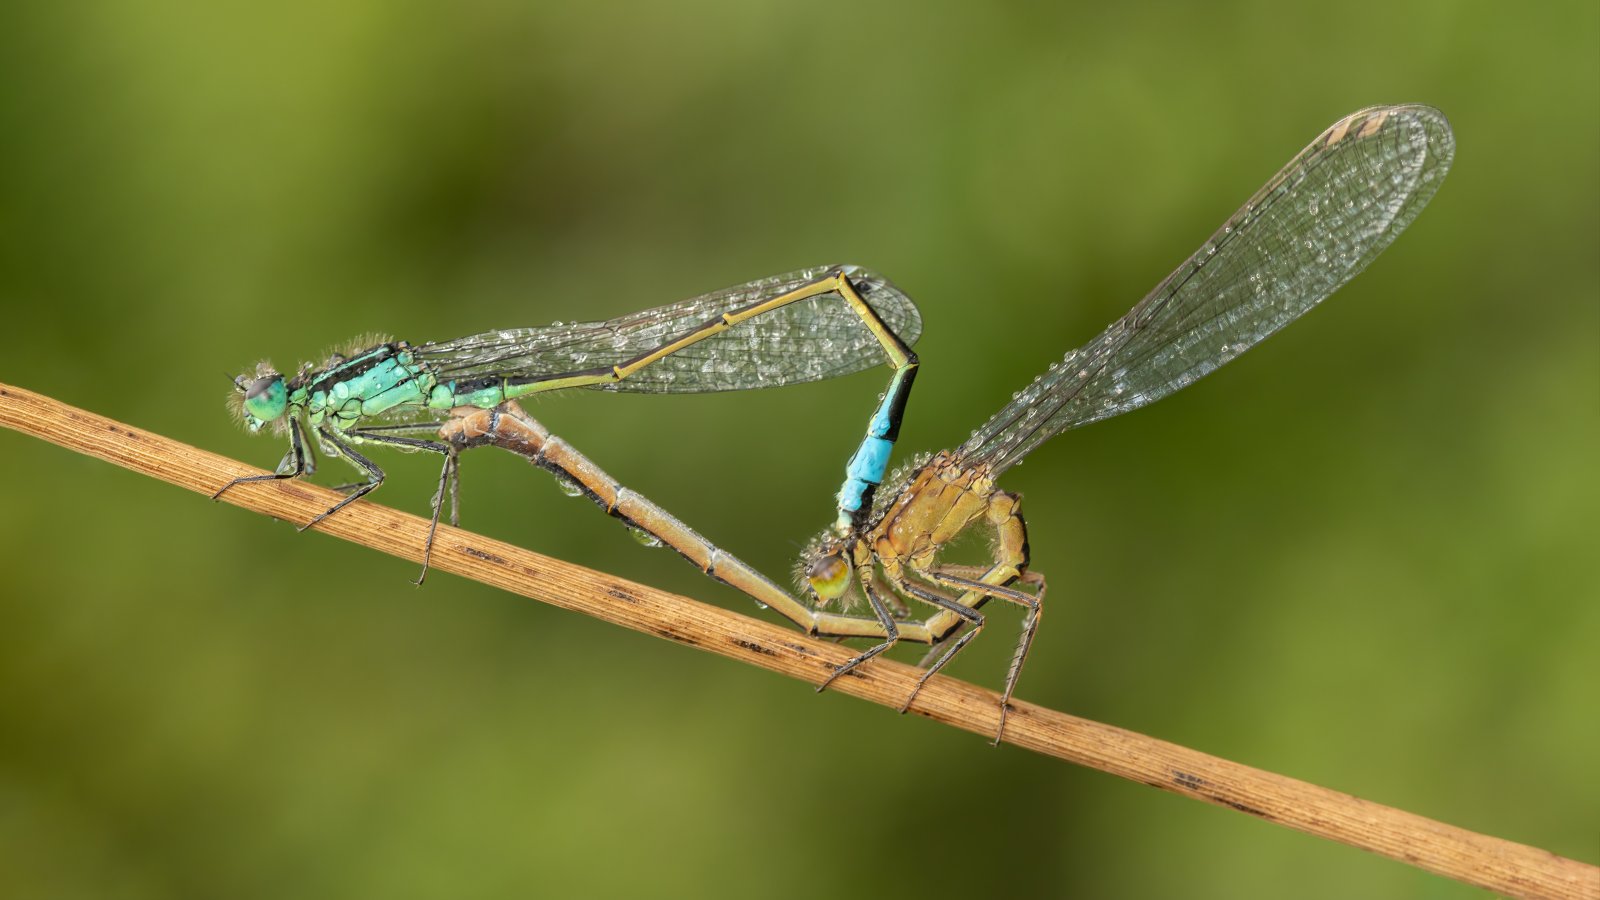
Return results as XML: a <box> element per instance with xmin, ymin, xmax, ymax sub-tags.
<box><xmin>0</xmin><ymin>384</ymin><xmax>1600</xmax><ymax>898</ymax></box>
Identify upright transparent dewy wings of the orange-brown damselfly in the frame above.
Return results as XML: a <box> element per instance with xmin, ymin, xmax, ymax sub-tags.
<box><xmin>960</xmin><ymin>106</ymin><xmax>1456</xmax><ymax>471</ymax></box>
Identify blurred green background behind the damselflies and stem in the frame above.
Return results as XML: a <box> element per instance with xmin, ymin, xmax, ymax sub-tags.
<box><xmin>0</xmin><ymin>0</ymin><xmax>1600</xmax><ymax>898</ymax></box>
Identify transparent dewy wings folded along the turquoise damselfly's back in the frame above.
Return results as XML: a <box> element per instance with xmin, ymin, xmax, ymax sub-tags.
<box><xmin>416</xmin><ymin>266</ymin><xmax>922</xmax><ymax>392</ymax></box>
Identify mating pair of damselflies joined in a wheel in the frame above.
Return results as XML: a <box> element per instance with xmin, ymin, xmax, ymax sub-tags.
<box><xmin>218</xmin><ymin>106</ymin><xmax>1454</xmax><ymax>741</ymax></box>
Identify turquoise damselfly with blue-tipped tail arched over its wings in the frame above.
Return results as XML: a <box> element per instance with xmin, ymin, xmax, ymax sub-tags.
<box><xmin>222</xmin><ymin>266</ymin><xmax>922</xmax><ymax>583</ymax></box>
